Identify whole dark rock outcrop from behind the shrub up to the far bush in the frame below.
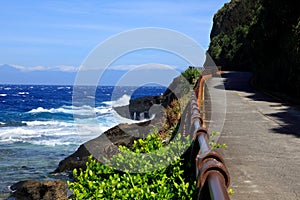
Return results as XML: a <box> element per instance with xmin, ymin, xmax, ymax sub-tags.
<box><xmin>53</xmin><ymin>74</ymin><xmax>190</xmax><ymax>173</ymax></box>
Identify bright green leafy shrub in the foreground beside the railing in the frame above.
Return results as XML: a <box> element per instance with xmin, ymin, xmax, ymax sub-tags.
<box><xmin>68</xmin><ymin>133</ymin><xmax>195</xmax><ymax>199</ymax></box>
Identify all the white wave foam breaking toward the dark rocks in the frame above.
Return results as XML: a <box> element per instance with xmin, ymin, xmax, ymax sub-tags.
<box><xmin>0</xmin><ymin>95</ymin><xmax>150</xmax><ymax>146</ymax></box>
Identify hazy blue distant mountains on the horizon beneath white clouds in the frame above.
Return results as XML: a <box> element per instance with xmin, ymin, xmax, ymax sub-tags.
<box><xmin>0</xmin><ymin>64</ymin><xmax>179</xmax><ymax>86</ymax></box>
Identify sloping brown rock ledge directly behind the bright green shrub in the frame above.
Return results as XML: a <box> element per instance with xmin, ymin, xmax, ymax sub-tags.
<box><xmin>53</xmin><ymin>105</ymin><xmax>165</xmax><ymax>173</ymax></box>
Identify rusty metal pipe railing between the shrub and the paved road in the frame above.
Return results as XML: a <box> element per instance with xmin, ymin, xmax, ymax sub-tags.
<box><xmin>189</xmin><ymin>92</ymin><xmax>230</xmax><ymax>200</ymax></box>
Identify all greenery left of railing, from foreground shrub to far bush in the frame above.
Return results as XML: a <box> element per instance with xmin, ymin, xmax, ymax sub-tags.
<box><xmin>68</xmin><ymin>68</ymin><xmax>205</xmax><ymax>199</ymax></box>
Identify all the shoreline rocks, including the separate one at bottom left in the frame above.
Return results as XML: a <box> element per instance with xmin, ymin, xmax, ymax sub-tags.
<box><xmin>7</xmin><ymin>92</ymin><xmax>174</xmax><ymax>200</ymax></box>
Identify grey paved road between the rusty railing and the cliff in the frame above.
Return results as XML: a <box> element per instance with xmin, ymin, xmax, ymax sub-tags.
<box><xmin>207</xmin><ymin>72</ymin><xmax>300</xmax><ymax>200</ymax></box>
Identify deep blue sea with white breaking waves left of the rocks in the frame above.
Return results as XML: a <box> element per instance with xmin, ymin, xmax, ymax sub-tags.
<box><xmin>0</xmin><ymin>85</ymin><xmax>166</xmax><ymax>199</ymax></box>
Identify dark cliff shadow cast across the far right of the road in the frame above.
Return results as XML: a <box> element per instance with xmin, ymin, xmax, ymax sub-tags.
<box><xmin>211</xmin><ymin>72</ymin><xmax>300</xmax><ymax>137</ymax></box>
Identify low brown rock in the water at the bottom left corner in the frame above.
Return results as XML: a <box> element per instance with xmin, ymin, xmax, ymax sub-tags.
<box><xmin>8</xmin><ymin>180</ymin><xmax>68</xmax><ymax>200</ymax></box>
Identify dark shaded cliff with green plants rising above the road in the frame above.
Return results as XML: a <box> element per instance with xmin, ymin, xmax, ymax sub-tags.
<box><xmin>208</xmin><ymin>0</ymin><xmax>300</xmax><ymax>97</ymax></box>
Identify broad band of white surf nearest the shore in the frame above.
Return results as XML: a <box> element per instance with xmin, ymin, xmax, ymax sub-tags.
<box><xmin>0</xmin><ymin>122</ymin><xmax>111</xmax><ymax>146</ymax></box>
